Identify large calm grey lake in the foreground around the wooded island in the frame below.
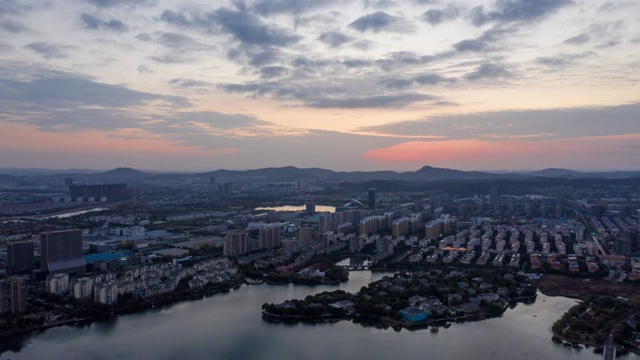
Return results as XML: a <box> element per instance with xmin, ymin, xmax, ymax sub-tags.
<box><xmin>0</xmin><ymin>271</ymin><xmax>620</xmax><ymax>360</ymax></box>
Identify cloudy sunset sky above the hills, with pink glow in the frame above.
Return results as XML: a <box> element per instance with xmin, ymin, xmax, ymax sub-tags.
<box><xmin>0</xmin><ymin>0</ymin><xmax>640</xmax><ymax>171</ymax></box>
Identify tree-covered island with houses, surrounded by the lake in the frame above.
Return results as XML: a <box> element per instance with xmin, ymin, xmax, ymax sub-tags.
<box><xmin>262</xmin><ymin>269</ymin><xmax>537</xmax><ymax>328</ymax></box>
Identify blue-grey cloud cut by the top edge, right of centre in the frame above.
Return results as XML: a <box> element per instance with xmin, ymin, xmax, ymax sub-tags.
<box><xmin>470</xmin><ymin>0</ymin><xmax>574</xmax><ymax>26</ymax></box>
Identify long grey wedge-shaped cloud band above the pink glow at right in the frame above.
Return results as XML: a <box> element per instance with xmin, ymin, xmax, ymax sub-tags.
<box><xmin>359</xmin><ymin>103</ymin><xmax>640</xmax><ymax>141</ymax></box>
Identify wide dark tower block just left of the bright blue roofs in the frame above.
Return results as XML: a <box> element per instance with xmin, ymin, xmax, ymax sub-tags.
<box><xmin>40</xmin><ymin>229</ymin><xmax>85</xmax><ymax>275</ymax></box>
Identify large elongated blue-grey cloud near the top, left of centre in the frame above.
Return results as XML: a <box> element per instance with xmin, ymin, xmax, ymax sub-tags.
<box><xmin>160</xmin><ymin>8</ymin><xmax>302</xmax><ymax>47</ymax></box>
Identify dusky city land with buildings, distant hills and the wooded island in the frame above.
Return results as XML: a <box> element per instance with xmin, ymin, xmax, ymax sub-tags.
<box><xmin>0</xmin><ymin>167</ymin><xmax>640</xmax><ymax>355</ymax></box>
